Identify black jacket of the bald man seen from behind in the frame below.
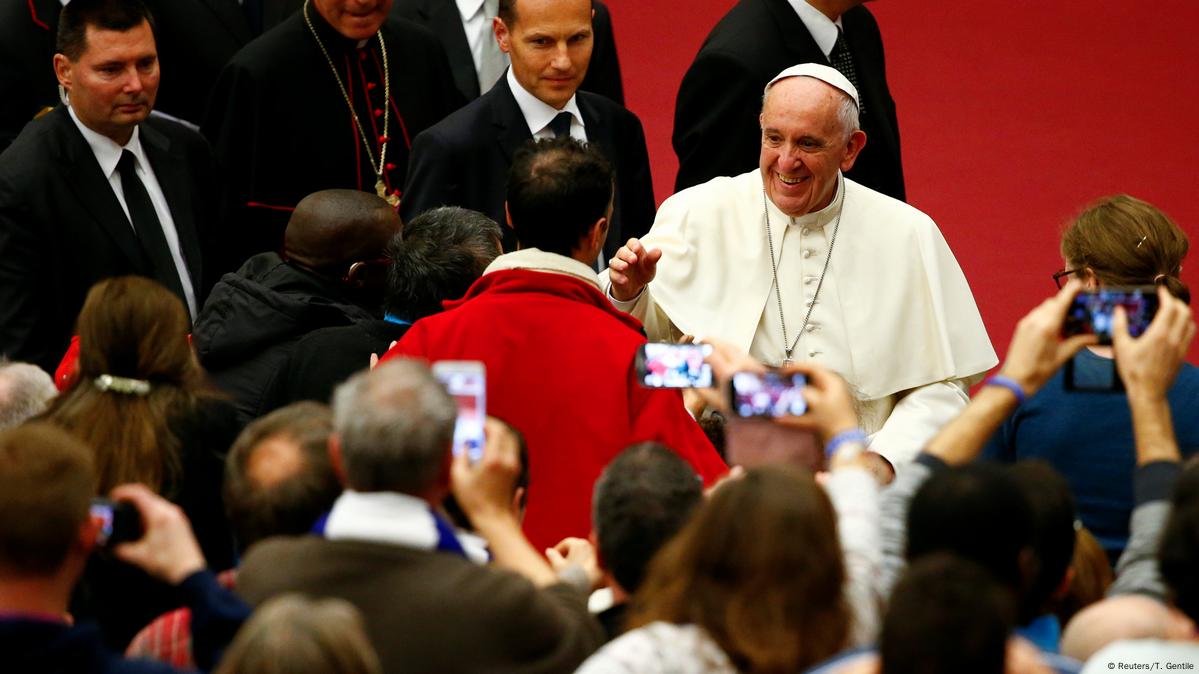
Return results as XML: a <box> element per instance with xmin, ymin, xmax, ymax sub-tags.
<box><xmin>192</xmin><ymin>253</ymin><xmax>375</xmax><ymax>423</ymax></box>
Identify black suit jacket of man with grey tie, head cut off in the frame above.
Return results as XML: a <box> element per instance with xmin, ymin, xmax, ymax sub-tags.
<box><xmin>391</xmin><ymin>0</ymin><xmax>625</xmax><ymax>106</ymax></box>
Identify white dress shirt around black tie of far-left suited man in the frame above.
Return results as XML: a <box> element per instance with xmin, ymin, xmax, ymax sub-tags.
<box><xmin>70</xmin><ymin>109</ymin><xmax>197</xmax><ymax>320</ymax></box>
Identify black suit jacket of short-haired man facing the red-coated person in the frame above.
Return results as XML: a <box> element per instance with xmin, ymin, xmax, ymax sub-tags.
<box><xmin>399</xmin><ymin>77</ymin><xmax>655</xmax><ymax>257</ymax></box>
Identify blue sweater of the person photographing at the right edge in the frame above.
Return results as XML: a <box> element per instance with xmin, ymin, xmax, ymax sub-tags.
<box><xmin>983</xmin><ymin>349</ymin><xmax>1199</xmax><ymax>559</ymax></box>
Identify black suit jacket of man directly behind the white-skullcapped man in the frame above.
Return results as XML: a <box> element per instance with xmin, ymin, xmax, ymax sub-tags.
<box><xmin>671</xmin><ymin>0</ymin><xmax>905</xmax><ymax>199</ymax></box>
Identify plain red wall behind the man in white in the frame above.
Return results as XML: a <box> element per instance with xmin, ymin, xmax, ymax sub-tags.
<box><xmin>608</xmin><ymin>0</ymin><xmax>1199</xmax><ymax>362</ymax></box>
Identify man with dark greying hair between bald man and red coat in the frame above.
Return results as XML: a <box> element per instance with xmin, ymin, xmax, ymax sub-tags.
<box><xmin>270</xmin><ymin>206</ymin><xmax>500</xmax><ymax>407</ymax></box>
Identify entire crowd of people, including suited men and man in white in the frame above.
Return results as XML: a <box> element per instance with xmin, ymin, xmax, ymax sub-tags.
<box><xmin>0</xmin><ymin>0</ymin><xmax>1199</xmax><ymax>674</ymax></box>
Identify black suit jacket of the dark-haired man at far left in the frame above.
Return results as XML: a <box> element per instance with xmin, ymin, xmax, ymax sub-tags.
<box><xmin>0</xmin><ymin>106</ymin><xmax>213</xmax><ymax>372</ymax></box>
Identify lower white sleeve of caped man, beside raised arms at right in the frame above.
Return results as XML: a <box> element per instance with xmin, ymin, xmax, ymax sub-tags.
<box><xmin>870</xmin><ymin>379</ymin><xmax>970</xmax><ymax>468</ymax></box>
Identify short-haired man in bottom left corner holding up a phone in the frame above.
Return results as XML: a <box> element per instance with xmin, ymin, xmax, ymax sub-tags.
<box><xmin>0</xmin><ymin>422</ymin><xmax>249</xmax><ymax>674</ymax></box>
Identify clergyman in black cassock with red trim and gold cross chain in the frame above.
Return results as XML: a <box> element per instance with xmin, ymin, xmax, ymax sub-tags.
<box><xmin>201</xmin><ymin>0</ymin><xmax>463</xmax><ymax>271</ymax></box>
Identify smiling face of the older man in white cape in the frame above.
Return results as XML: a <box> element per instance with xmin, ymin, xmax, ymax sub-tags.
<box><xmin>758</xmin><ymin>77</ymin><xmax>866</xmax><ymax>217</ymax></box>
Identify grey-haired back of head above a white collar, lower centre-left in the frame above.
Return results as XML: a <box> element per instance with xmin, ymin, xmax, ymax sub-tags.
<box><xmin>333</xmin><ymin>359</ymin><xmax>458</xmax><ymax>494</ymax></box>
